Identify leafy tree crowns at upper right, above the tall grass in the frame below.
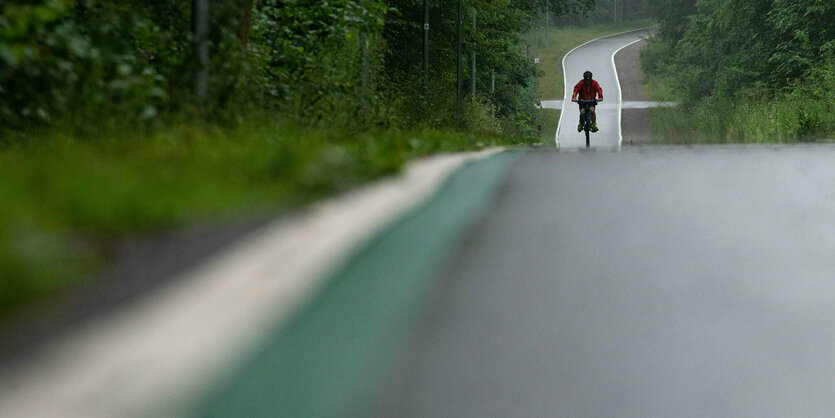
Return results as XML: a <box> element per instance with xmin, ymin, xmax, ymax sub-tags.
<box><xmin>644</xmin><ymin>0</ymin><xmax>835</xmax><ymax>101</ymax></box>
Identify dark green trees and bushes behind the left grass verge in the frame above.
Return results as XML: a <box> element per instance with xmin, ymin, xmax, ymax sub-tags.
<box><xmin>0</xmin><ymin>0</ymin><xmax>594</xmax><ymax>134</ymax></box>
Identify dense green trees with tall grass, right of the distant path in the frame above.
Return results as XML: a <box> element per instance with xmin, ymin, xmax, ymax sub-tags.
<box><xmin>642</xmin><ymin>0</ymin><xmax>835</xmax><ymax>138</ymax></box>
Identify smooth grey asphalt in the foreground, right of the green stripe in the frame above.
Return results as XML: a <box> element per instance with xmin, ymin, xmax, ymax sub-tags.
<box><xmin>376</xmin><ymin>145</ymin><xmax>835</xmax><ymax>417</ymax></box>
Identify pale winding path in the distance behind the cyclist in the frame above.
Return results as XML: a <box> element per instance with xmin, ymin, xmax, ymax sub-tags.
<box><xmin>556</xmin><ymin>29</ymin><xmax>653</xmax><ymax>149</ymax></box>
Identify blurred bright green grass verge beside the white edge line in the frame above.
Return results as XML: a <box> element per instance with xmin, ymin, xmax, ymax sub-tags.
<box><xmin>0</xmin><ymin>119</ymin><xmax>536</xmax><ymax>318</ymax></box>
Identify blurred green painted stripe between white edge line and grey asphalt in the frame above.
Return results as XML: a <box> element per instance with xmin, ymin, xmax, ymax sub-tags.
<box><xmin>195</xmin><ymin>152</ymin><xmax>522</xmax><ymax>417</ymax></box>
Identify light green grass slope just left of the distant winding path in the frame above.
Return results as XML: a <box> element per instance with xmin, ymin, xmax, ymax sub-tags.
<box><xmin>525</xmin><ymin>20</ymin><xmax>652</xmax><ymax>144</ymax></box>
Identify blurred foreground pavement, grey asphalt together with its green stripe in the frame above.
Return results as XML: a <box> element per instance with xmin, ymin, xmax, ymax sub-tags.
<box><xmin>0</xmin><ymin>144</ymin><xmax>835</xmax><ymax>416</ymax></box>
